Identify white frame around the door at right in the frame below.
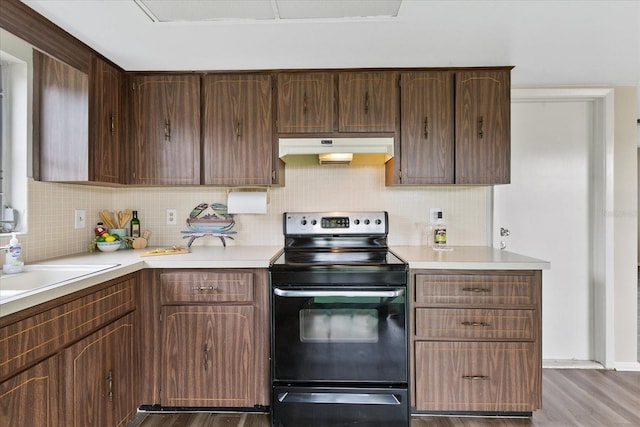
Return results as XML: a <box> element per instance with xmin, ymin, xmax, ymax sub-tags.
<box><xmin>496</xmin><ymin>88</ymin><xmax>615</xmax><ymax>368</ymax></box>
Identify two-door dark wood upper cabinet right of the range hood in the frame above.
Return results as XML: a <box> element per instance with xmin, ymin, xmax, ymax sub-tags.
<box><xmin>387</xmin><ymin>67</ymin><xmax>511</xmax><ymax>185</ymax></box>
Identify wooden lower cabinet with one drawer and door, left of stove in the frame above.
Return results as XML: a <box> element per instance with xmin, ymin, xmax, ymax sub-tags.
<box><xmin>158</xmin><ymin>269</ymin><xmax>269</xmax><ymax>408</ymax></box>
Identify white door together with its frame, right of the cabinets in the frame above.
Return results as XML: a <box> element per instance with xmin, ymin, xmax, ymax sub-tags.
<box><xmin>492</xmin><ymin>89</ymin><xmax>613</xmax><ymax>366</ymax></box>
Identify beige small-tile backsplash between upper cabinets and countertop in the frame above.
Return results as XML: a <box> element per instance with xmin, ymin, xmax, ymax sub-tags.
<box><xmin>0</xmin><ymin>157</ymin><xmax>491</xmax><ymax>262</ymax></box>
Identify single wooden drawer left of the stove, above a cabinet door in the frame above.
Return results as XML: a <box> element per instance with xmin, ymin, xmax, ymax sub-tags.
<box><xmin>160</xmin><ymin>271</ymin><xmax>253</xmax><ymax>304</ymax></box>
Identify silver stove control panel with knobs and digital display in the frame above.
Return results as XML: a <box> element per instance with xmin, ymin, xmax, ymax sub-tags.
<box><xmin>283</xmin><ymin>211</ymin><xmax>389</xmax><ymax>235</ymax></box>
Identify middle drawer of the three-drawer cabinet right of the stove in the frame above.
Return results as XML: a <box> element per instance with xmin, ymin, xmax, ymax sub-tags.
<box><xmin>415</xmin><ymin>308</ymin><xmax>536</xmax><ymax>340</ymax></box>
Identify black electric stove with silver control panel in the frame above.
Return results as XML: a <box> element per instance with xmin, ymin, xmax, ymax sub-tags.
<box><xmin>269</xmin><ymin>212</ymin><xmax>409</xmax><ymax>427</ymax></box>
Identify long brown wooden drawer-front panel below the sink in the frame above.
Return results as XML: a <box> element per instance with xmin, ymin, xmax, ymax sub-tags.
<box><xmin>0</xmin><ymin>279</ymin><xmax>135</xmax><ymax>380</ymax></box>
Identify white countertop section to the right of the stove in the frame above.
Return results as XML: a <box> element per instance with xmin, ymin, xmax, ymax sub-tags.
<box><xmin>391</xmin><ymin>246</ymin><xmax>550</xmax><ymax>270</ymax></box>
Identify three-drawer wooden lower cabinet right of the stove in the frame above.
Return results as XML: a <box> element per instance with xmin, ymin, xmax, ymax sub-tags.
<box><xmin>411</xmin><ymin>270</ymin><xmax>542</xmax><ymax>414</ymax></box>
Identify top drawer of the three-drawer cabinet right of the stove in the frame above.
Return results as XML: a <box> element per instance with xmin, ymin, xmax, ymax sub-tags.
<box><xmin>415</xmin><ymin>274</ymin><xmax>537</xmax><ymax>305</ymax></box>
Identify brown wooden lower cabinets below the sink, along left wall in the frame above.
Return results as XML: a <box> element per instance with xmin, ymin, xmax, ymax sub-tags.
<box><xmin>0</xmin><ymin>275</ymin><xmax>138</xmax><ymax>427</ymax></box>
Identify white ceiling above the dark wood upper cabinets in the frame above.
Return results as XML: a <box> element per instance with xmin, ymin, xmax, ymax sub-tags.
<box><xmin>17</xmin><ymin>0</ymin><xmax>640</xmax><ymax>92</ymax></box>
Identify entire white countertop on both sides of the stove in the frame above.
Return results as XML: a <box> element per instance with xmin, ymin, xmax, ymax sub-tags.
<box><xmin>0</xmin><ymin>246</ymin><xmax>549</xmax><ymax>316</ymax></box>
